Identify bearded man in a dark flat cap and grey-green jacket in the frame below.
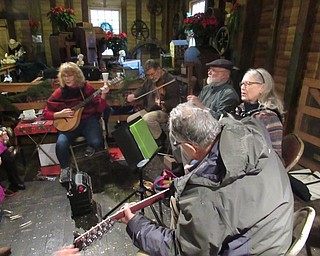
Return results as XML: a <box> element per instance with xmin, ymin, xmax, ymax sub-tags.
<box><xmin>170</xmin><ymin>59</ymin><xmax>240</xmax><ymax>166</ymax></box>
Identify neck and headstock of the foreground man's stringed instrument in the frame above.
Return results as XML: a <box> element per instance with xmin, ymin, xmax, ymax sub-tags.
<box><xmin>73</xmin><ymin>188</ymin><xmax>170</xmax><ymax>251</ymax></box>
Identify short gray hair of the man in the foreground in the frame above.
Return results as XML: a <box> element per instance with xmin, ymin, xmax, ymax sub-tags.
<box><xmin>169</xmin><ymin>102</ymin><xmax>221</xmax><ymax>148</ymax></box>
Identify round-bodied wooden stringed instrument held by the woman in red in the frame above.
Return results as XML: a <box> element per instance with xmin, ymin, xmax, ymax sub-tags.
<box><xmin>53</xmin><ymin>77</ymin><xmax>123</xmax><ymax>132</ymax></box>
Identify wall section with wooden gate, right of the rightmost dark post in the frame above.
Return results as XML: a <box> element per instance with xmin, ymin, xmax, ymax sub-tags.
<box><xmin>294</xmin><ymin>1</ymin><xmax>320</xmax><ymax>171</ymax></box>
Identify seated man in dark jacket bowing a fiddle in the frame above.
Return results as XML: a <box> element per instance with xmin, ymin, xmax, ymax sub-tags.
<box><xmin>127</xmin><ymin>59</ymin><xmax>180</xmax><ymax>146</ymax></box>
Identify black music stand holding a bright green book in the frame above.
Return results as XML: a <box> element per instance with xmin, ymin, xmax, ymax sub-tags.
<box><xmin>103</xmin><ymin>117</ymin><xmax>163</xmax><ymax>225</ymax></box>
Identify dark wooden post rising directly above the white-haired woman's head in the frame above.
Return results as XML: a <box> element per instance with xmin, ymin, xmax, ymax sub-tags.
<box><xmin>265</xmin><ymin>0</ymin><xmax>283</xmax><ymax>74</ymax></box>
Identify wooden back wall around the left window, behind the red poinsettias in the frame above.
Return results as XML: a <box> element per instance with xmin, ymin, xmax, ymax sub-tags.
<box><xmin>0</xmin><ymin>0</ymin><xmax>178</xmax><ymax>66</ymax></box>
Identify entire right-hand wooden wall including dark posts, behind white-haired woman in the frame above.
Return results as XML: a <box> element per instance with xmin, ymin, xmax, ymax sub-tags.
<box><xmin>245</xmin><ymin>0</ymin><xmax>320</xmax><ymax>171</ymax></box>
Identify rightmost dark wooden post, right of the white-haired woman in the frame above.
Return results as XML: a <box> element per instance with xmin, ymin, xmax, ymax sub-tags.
<box><xmin>284</xmin><ymin>0</ymin><xmax>317</xmax><ymax>134</ymax></box>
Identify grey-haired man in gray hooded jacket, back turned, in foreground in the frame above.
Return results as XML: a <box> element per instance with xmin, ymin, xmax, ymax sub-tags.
<box><xmin>122</xmin><ymin>103</ymin><xmax>293</xmax><ymax>255</ymax></box>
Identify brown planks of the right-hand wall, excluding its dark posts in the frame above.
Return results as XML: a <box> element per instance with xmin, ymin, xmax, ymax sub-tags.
<box><xmin>253</xmin><ymin>0</ymin><xmax>320</xmax><ymax>171</ymax></box>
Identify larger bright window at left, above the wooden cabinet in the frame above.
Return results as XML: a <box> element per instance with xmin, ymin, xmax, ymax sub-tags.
<box><xmin>90</xmin><ymin>9</ymin><xmax>120</xmax><ymax>34</ymax></box>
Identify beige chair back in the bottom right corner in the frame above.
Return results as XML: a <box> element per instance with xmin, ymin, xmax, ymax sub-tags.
<box><xmin>286</xmin><ymin>206</ymin><xmax>316</xmax><ymax>256</ymax></box>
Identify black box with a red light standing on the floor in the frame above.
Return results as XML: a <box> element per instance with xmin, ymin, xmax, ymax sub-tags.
<box><xmin>67</xmin><ymin>172</ymin><xmax>93</xmax><ymax>218</ymax></box>
